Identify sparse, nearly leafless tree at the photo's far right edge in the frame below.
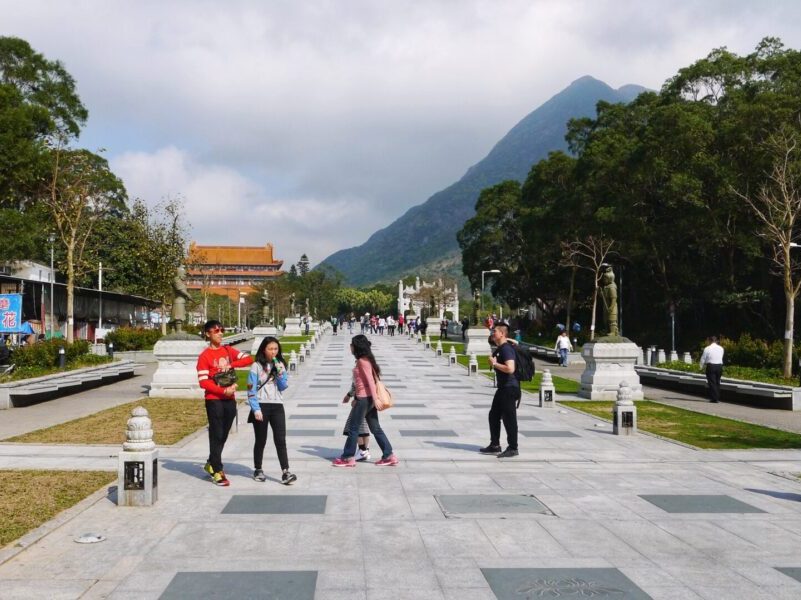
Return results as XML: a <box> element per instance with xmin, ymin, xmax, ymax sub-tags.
<box><xmin>738</xmin><ymin>126</ymin><xmax>801</xmax><ymax>379</ymax></box>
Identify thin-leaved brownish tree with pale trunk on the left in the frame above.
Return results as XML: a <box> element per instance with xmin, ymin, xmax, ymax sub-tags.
<box><xmin>42</xmin><ymin>147</ymin><xmax>125</xmax><ymax>343</ymax></box>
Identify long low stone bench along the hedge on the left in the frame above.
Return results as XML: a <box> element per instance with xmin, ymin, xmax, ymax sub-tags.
<box><xmin>0</xmin><ymin>360</ymin><xmax>144</xmax><ymax>410</ymax></box>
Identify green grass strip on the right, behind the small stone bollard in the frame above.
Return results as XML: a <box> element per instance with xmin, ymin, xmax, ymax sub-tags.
<box><xmin>559</xmin><ymin>400</ymin><xmax>801</xmax><ymax>450</ymax></box>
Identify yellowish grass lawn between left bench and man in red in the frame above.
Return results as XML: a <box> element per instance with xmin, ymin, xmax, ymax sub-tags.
<box><xmin>4</xmin><ymin>398</ymin><xmax>207</xmax><ymax>446</ymax></box>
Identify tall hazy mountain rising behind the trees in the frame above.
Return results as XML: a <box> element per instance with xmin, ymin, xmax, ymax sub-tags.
<box><xmin>321</xmin><ymin>76</ymin><xmax>645</xmax><ymax>286</ymax></box>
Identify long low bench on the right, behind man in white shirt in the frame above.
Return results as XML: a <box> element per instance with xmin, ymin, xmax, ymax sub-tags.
<box><xmin>634</xmin><ymin>365</ymin><xmax>801</xmax><ymax>410</ymax></box>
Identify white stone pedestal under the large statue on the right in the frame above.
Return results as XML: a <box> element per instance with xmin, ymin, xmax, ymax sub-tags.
<box><xmin>579</xmin><ymin>338</ymin><xmax>643</xmax><ymax>400</ymax></box>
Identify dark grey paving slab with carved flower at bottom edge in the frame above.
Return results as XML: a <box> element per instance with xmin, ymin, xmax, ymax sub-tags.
<box><xmin>481</xmin><ymin>568</ymin><xmax>651</xmax><ymax>600</ymax></box>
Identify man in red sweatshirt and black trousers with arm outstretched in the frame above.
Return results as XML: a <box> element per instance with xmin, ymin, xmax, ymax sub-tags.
<box><xmin>197</xmin><ymin>319</ymin><xmax>253</xmax><ymax>486</ymax></box>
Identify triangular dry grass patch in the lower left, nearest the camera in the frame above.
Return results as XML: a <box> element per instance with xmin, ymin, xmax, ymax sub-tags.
<box><xmin>0</xmin><ymin>470</ymin><xmax>117</xmax><ymax>547</ymax></box>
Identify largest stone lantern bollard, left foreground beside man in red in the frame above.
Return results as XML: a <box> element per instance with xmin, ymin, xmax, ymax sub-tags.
<box><xmin>117</xmin><ymin>406</ymin><xmax>159</xmax><ymax>506</ymax></box>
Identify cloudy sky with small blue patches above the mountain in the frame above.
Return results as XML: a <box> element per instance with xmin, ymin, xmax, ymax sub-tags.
<box><xmin>0</xmin><ymin>0</ymin><xmax>801</xmax><ymax>268</ymax></box>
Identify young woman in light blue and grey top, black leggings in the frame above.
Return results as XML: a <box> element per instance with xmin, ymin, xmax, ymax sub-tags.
<box><xmin>248</xmin><ymin>336</ymin><xmax>298</xmax><ymax>485</ymax></box>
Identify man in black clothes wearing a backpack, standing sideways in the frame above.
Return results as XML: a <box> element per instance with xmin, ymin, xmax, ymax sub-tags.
<box><xmin>479</xmin><ymin>323</ymin><xmax>520</xmax><ymax>458</ymax></box>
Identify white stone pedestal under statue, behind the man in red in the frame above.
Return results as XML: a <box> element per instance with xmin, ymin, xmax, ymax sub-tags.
<box><xmin>148</xmin><ymin>334</ymin><xmax>208</xmax><ymax>398</ymax></box>
